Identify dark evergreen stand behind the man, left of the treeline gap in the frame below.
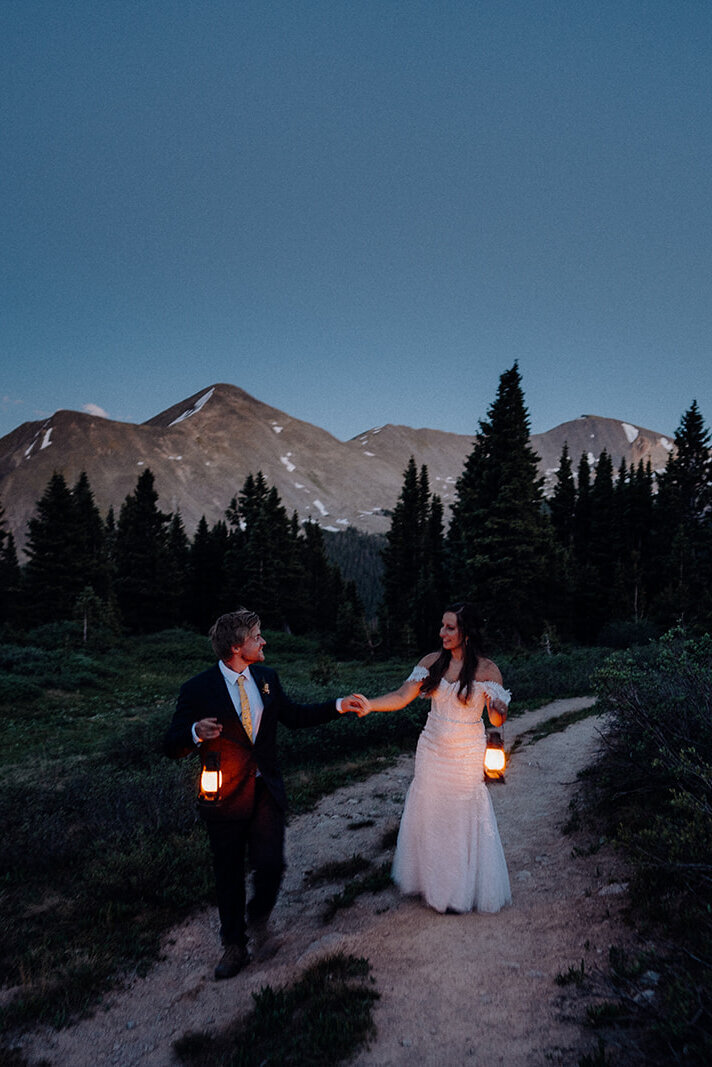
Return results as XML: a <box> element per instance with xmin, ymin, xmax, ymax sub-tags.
<box><xmin>0</xmin><ymin>468</ymin><xmax>369</xmax><ymax>655</ymax></box>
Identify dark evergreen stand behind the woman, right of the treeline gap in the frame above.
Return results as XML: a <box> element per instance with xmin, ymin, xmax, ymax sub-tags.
<box><xmin>381</xmin><ymin>364</ymin><xmax>712</xmax><ymax>652</ymax></box>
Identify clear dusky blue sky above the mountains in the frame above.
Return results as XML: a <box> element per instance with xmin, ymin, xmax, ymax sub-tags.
<box><xmin>0</xmin><ymin>0</ymin><xmax>712</xmax><ymax>440</ymax></box>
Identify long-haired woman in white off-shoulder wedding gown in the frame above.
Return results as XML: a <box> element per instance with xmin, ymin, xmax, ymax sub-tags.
<box><xmin>350</xmin><ymin>604</ymin><xmax>511</xmax><ymax>911</ymax></box>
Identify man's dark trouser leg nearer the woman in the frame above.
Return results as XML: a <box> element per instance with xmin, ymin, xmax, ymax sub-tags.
<box><xmin>248</xmin><ymin>778</ymin><xmax>284</xmax><ymax>923</ymax></box>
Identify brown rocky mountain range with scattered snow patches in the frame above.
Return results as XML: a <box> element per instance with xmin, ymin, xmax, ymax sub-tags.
<box><xmin>0</xmin><ymin>384</ymin><xmax>671</xmax><ymax>545</ymax></box>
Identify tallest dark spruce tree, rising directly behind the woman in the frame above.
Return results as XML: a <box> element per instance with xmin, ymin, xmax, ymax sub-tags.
<box><xmin>449</xmin><ymin>363</ymin><xmax>558</xmax><ymax>643</ymax></box>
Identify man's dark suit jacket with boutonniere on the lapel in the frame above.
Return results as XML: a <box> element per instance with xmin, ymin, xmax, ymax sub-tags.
<box><xmin>163</xmin><ymin>664</ymin><xmax>338</xmax><ymax>819</ymax></box>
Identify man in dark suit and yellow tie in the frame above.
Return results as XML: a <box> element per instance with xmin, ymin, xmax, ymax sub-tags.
<box><xmin>164</xmin><ymin>608</ymin><xmax>361</xmax><ymax>978</ymax></box>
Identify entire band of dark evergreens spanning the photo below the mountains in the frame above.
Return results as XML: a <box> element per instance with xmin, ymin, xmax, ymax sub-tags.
<box><xmin>0</xmin><ymin>364</ymin><xmax>712</xmax><ymax>656</ymax></box>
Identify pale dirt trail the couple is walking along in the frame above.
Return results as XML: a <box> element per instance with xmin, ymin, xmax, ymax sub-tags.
<box><xmin>16</xmin><ymin>698</ymin><xmax>623</xmax><ymax>1067</ymax></box>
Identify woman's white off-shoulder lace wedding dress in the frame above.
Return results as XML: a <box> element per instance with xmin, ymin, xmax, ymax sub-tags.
<box><xmin>393</xmin><ymin>667</ymin><xmax>511</xmax><ymax>911</ymax></box>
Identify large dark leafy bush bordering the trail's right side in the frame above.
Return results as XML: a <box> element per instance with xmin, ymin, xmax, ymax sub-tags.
<box><xmin>584</xmin><ymin>631</ymin><xmax>712</xmax><ymax>1067</ymax></box>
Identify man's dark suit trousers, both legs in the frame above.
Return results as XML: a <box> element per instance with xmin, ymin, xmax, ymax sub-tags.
<box><xmin>206</xmin><ymin>778</ymin><xmax>285</xmax><ymax>946</ymax></box>
